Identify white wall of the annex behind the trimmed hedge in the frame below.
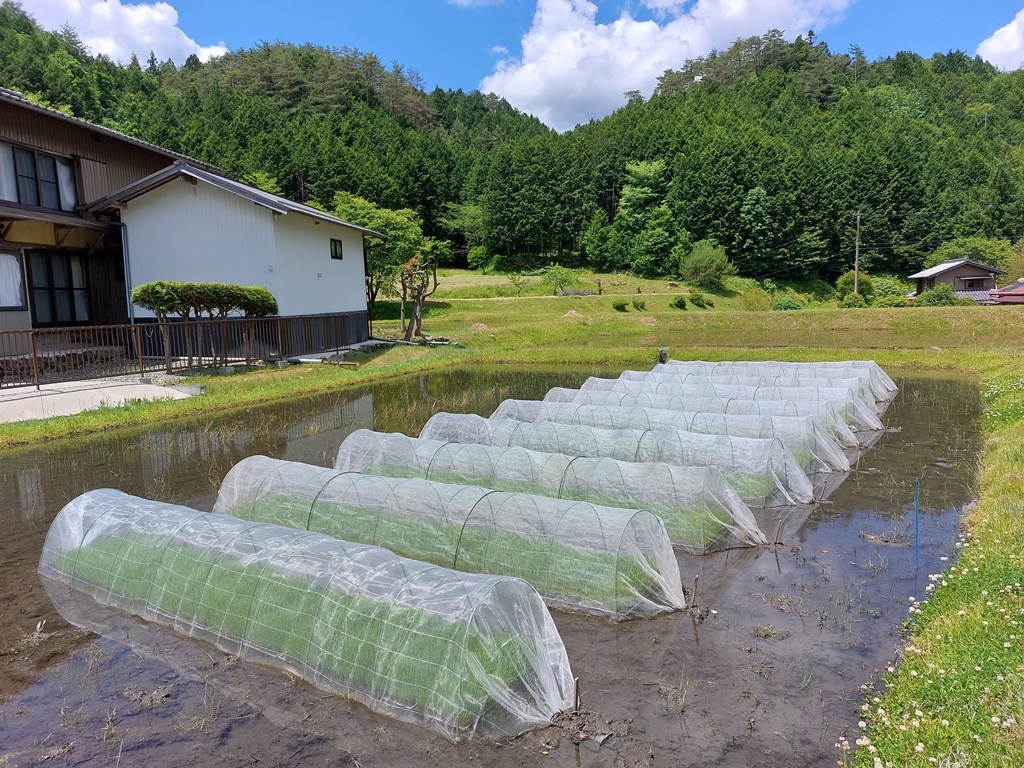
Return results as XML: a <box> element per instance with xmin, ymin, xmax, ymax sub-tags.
<box><xmin>121</xmin><ymin>179</ymin><xmax>366</xmax><ymax>317</ymax></box>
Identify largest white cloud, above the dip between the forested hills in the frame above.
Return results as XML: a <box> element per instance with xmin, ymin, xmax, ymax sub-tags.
<box><xmin>480</xmin><ymin>0</ymin><xmax>853</xmax><ymax>130</ymax></box>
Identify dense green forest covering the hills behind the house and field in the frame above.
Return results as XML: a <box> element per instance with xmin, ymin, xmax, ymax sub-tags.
<box><xmin>0</xmin><ymin>0</ymin><xmax>1024</xmax><ymax>282</ymax></box>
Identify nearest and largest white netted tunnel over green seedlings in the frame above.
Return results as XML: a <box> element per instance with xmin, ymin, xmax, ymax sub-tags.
<box><xmin>39</xmin><ymin>488</ymin><xmax>573</xmax><ymax>739</ymax></box>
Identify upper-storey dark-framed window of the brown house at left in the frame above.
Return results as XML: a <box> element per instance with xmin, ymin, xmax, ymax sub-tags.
<box><xmin>0</xmin><ymin>141</ymin><xmax>78</xmax><ymax>213</ymax></box>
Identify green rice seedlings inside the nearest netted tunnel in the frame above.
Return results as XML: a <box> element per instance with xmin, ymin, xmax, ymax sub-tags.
<box><xmin>53</xmin><ymin>534</ymin><xmax>530</xmax><ymax>734</ymax></box>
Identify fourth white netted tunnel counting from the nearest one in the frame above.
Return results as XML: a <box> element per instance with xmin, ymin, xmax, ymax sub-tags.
<box><xmin>420</xmin><ymin>413</ymin><xmax>814</xmax><ymax>507</ymax></box>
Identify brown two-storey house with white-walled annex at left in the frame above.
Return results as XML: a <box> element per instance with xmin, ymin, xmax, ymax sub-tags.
<box><xmin>0</xmin><ymin>88</ymin><xmax>382</xmax><ymax>341</ymax></box>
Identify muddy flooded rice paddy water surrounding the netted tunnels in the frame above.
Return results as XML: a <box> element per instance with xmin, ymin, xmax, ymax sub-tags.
<box><xmin>0</xmin><ymin>369</ymin><xmax>981</xmax><ymax>768</ymax></box>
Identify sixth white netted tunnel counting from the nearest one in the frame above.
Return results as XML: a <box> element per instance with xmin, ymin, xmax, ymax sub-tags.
<box><xmin>544</xmin><ymin>387</ymin><xmax>883</xmax><ymax>449</ymax></box>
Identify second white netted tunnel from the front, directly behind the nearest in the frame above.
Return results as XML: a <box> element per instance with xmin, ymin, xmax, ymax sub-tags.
<box><xmin>214</xmin><ymin>456</ymin><xmax>686</xmax><ymax>621</ymax></box>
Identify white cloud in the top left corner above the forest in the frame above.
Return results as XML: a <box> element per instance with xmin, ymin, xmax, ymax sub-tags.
<box><xmin>22</xmin><ymin>0</ymin><xmax>227</xmax><ymax>65</ymax></box>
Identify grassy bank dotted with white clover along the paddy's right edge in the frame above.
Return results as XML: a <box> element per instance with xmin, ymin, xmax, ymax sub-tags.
<box><xmin>850</xmin><ymin>364</ymin><xmax>1024</xmax><ymax>768</ymax></box>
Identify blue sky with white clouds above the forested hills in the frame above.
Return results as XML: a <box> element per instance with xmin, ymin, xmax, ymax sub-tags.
<box><xmin>22</xmin><ymin>0</ymin><xmax>1024</xmax><ymax>131</ymax></box>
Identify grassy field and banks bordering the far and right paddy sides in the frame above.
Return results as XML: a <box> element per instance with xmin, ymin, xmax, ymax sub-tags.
<box><xmin>0</xmin><ymin>274</ymin><xmax>1024</xmax><ymax>768</ymax></box>
